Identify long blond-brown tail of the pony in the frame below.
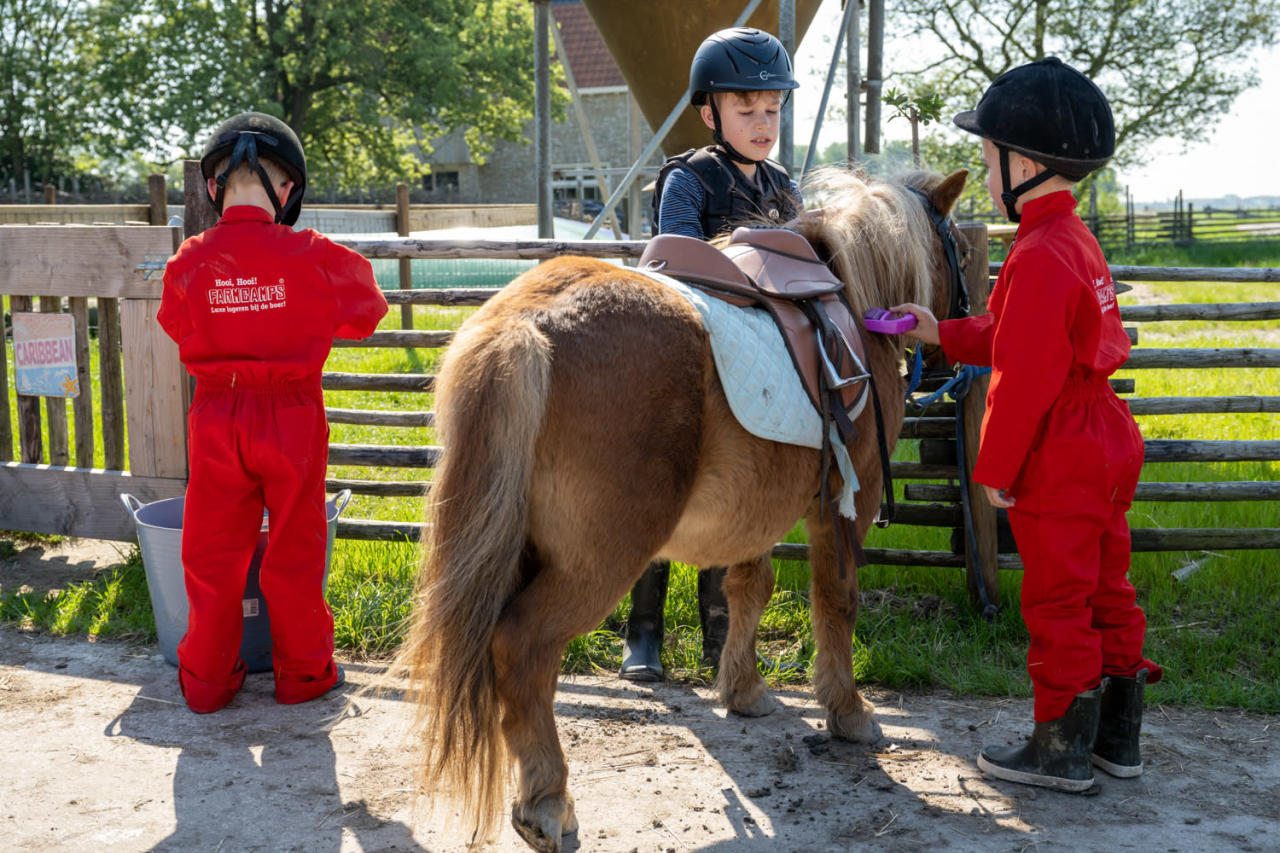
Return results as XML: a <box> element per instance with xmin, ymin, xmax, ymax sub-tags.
<box><xmin>397</xmin><ymin>320</ymin><xmax>550</xmax><ymax>839</ymax></box>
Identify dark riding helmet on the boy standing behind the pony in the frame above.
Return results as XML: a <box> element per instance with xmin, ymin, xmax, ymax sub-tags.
<box><xmin>689</xmin><ymin>27</ymin><xmax>800</xmax><ymax>163</ymax></box>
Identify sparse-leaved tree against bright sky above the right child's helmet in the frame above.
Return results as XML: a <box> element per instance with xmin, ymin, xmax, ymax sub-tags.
<box><xmin>892</xmin><ymin>0</ymin><xmax>1280</xmax><ymax>167</ymax></box>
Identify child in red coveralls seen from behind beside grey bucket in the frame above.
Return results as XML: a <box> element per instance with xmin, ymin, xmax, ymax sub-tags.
<box><xmin>157</xmin><ymin>113</ymin><xmax>387</xmax><ymax>713</ymax></box>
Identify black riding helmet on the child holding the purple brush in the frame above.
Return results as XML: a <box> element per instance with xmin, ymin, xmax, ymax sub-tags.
<box><xmin>954</xmin><ymin>56</ymin><xmax>1116</xmax><ymax>222</ymax></box>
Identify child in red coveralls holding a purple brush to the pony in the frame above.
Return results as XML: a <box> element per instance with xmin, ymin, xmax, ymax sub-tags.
<box><xmin>893</xmin><ymin>58</ymin><xmax>1162</xmax><ymax>792</ymax></box>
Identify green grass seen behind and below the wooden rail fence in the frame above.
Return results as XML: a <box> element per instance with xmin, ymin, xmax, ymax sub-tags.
<box><xmin>0</xmin><ymin>235</ymin><xmax>1280</xmax><ymax>713</ymax></box>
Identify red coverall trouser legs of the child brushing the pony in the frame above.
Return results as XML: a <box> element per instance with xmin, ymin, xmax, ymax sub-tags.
<box><xmin>1009</xmin><ymin>383</ymin><xmax>1160</xmax><ymax>722</ymax></box>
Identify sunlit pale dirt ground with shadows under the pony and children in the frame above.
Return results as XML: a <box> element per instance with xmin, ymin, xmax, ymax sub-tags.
<box><xmin>0</xmin><ymin>540</ymin><xmax>1280</xmax><ymax>853</ymax></box>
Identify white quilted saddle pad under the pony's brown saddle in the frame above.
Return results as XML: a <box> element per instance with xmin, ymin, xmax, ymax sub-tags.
<box><xmin>635</xmin><ymin>269</ymin><xmax>867</xmax><ymax>519</ymax></box>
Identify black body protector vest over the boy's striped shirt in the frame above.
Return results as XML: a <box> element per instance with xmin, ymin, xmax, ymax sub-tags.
<box><xmin>653</xmin><ymin>145</ymin><xmax>800</xmax><ymax>240</ymax></box>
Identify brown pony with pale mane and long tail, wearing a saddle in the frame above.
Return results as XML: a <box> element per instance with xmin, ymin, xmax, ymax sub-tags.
<box><xmin>398</xmin><ymin>172</ymin><xmax>966</xmax><ymax>850</ymax></box>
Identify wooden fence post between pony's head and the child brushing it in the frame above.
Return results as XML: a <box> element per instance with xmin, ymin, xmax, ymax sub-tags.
<box><xmin>961</xmin><ymin>224</ymin><xmax>1000</xmax><ymax>605</ymax></box>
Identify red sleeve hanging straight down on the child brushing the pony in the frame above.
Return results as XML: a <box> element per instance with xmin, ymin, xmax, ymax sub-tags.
<box><xmin>973</xmin><ymin>249</ymin><xmax>1080</xmax><ymax>497</ymax></box>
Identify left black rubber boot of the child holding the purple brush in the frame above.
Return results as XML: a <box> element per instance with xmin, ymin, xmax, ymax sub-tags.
<box><xmin>978</xmin><ymin>685</ymin><xmax>1102</xmax><ymax>793</ymax></box>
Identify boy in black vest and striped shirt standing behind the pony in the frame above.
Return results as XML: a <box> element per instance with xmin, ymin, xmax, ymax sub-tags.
<box><xmin>621</xmin><ymin>27</ymin><xmax>801</xmax><ymax>681</ymax></box>
